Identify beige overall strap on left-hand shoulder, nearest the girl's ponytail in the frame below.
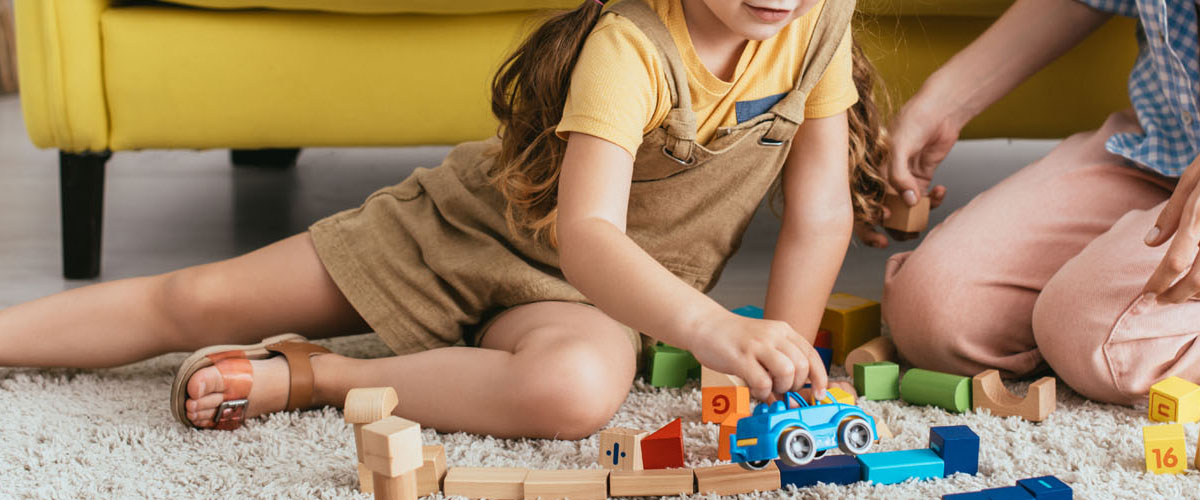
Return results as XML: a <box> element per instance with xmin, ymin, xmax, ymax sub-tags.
<box><xmin>610</xmin><ymin>0</ymin><xmax>700</xmax><ymax>163</ymax></box>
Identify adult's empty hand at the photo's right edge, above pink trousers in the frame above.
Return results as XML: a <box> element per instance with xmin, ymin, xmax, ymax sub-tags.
<box><xmin>1142</xmin><ymin>158</ymin><xmax>1200</xmax><ymax>303</ymax></box>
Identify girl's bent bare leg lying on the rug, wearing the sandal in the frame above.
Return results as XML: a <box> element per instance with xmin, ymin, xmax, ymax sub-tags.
<box><xmin>193</xmin><ymin>302</ymin><xmax>636</xmax><ymax>439</ymax></box>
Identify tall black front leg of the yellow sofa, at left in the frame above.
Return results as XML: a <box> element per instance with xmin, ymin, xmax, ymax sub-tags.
<box><xmin>59</xmin><ymin>151</ymin><xmax>112</xmax><ymax>279</ymax></box>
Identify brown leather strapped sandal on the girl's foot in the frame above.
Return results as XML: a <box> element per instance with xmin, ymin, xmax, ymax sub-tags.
<box><xmin>170</xmin><ymin>333</ymin><xmax>329</xmax><ymax>430</ymax></box>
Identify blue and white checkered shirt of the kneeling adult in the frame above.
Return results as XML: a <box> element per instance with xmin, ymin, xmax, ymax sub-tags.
<box><xmin>1079</xmin><ymin>0</ymin><xmax>1200</xmax><ymax>177</ymax></box>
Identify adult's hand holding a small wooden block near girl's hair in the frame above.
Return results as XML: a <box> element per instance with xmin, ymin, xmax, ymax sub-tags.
<box><xmin>854</xmin><ymin>92</ymin><xmax>962</xmax><ymax>248</ymax></box>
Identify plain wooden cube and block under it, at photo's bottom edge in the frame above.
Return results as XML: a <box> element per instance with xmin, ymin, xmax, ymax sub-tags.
<box><xmin>362</xmin><ymin>416</ymin><xmax>425</xmax><ymax>500</ymax></box>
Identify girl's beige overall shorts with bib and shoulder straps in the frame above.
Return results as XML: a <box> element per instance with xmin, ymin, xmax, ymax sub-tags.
<box><xmin>310</xmin><ymin>0</ymin><xmax>854</xmax><ymax>354</ymax></box>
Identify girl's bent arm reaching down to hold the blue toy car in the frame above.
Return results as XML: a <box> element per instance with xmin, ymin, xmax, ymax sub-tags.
<box><xmin>558</xmin><ymin>133</ymin><xmax>830</xmax><ymax>399</ymax></box>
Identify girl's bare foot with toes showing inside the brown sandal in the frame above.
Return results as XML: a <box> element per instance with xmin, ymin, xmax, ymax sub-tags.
<box><xmin>185</xmin><ymin>356</ymin><xmax>294</xmax><ymax>427</ymax></box>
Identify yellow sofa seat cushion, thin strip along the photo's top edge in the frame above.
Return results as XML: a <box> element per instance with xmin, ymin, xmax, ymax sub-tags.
<box><xmin>147</xmin><ymin>0</ymin><xmax>1013</xmax><ymax>17</ymax></box>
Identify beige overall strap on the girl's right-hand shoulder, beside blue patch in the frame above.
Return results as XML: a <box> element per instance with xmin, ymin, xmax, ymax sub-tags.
<box><xmin>760</xmin><ymin>0</ymin><xmax>856</xmax><ymax>145</ymax></box>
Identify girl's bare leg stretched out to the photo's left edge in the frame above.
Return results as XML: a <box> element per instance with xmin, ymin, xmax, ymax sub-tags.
<box><xmin>0</xmin><ymin>234</ymin><xmax>367</xmax><ymax>368</ymax></box>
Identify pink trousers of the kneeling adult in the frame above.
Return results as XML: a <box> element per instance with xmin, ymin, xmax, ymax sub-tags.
<box><xmin>883</xmin><ymin>112</ymin><xmax>1200</xmax><ymax>404</ymax></box>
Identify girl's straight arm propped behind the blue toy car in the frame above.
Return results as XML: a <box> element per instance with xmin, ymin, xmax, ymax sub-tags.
<box><xmin>764</xmin><ymin>113</ymin><xmax>854</xmax><ymax>352</ymax></box>
